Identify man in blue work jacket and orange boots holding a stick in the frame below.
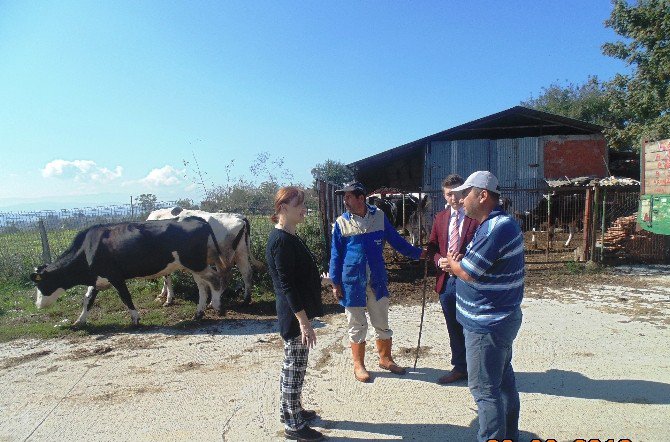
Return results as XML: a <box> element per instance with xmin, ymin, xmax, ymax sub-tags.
<box><xmin>329</xmin><ymin>182</ymin><xmax>425</xmax><ymax>382</ymax></box>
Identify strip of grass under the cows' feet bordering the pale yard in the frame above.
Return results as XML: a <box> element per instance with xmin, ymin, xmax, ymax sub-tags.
<box><xmin>0</xmin><ymin>273</ymin><xmax>288</xmax><ymax>342</ymax></box>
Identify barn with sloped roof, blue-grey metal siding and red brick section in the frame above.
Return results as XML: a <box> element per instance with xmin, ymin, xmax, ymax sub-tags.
<box><xmin>349</xmin><ymin>106</ymin><xmax>609</xmax><ymax>199</ymax></box>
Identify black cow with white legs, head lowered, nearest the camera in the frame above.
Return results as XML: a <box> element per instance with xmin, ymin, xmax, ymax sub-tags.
<box><xmin>30</xmin><ymin>217</ymin><xmax>222</xmax><ymax>325</ymax></box>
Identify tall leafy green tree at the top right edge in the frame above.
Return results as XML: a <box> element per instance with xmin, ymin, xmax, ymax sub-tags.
<box><xmin>602</xmin><ymin>0</ymin><xmax>670</xmax><ymax>149</ymax></box>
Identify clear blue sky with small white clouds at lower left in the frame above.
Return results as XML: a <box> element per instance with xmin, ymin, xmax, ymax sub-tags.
<box><xmin>0</xmin><ymin>0</ymin><xmax>626</xmax><ymax>207</ymax></box>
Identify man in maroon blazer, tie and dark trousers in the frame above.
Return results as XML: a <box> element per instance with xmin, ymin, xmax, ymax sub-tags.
<box><xmin>428</xmin><ymin>174</ymin><xmax>479</xmax><ymax>384</ymax></box>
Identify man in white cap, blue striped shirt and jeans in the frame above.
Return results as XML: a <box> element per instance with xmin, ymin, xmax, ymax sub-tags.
<box><xmin>448</xmin><ymin>171</ymin><xmax>524</xmax><ymax>442</ymax></box>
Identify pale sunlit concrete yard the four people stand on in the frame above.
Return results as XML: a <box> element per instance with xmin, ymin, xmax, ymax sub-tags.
<box><xmin>0</xmin><ymin>263</ymin><xmax>670</xmax><ymax>442</ymax></box>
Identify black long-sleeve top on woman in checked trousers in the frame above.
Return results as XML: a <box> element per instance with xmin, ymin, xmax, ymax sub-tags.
<box><xmin>265</xmin><ymin>228</ymin><xmax>323</xmax><ymax>340</ymax></box>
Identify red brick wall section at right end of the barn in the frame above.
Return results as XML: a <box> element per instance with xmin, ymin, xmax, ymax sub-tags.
<box><xmin>544</xmin><ymin>138</ymin><xmax>608</xmax><ymax>179</ymax></box>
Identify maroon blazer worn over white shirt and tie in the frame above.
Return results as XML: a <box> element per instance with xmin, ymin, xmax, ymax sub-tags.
<box><xmin>428</xmin><ymin>207</ymin><xmax>479</xmax><ymax>293</ymax></box>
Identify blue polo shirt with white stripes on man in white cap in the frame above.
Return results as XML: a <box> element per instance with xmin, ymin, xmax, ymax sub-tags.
<box><xmin>456</xmin><ymin>206</ymin><xmax>525</xmax><ymax>333</ymax></box>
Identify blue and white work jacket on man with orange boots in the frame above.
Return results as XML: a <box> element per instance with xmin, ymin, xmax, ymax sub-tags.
<box><xmin>329</xmin><ymin>205</ymin><xmax>421</xmax><ymax>307</ymax></box>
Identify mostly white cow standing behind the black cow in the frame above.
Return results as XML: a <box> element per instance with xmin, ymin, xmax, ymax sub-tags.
<box><xmin>147</xmin><ymin>207</ymin><xmax>263</xmax><ymax>306</ymax></box>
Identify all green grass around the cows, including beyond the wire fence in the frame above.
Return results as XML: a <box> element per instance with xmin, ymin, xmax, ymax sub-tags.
<box><xmin>0</xmin><ymin>215</ymin><xmax>324</xmax><ymax>341</ymax></box>
